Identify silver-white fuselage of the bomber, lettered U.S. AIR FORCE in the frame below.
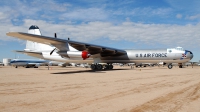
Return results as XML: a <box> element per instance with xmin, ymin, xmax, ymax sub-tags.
<box><xmin>26</xmin><ymin>48</ymin><xmax>193</xmax><ymax>63</ymax></box>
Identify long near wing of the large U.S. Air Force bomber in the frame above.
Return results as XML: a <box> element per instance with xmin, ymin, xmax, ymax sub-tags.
<box><xmin>6</xmin><ymin>32</ymin><xmax>126</xmax><ymax>57</ymax></box>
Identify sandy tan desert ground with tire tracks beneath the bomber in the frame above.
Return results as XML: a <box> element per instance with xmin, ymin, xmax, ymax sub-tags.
<box><xmin>0</xmin><ymin>66</ymin><xmax>200</xmax><ymax>112</ymax></box>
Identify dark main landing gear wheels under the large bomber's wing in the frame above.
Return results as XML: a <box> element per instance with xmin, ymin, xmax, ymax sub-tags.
<box><xmin>91</xmin><ymin>64</ymin><xmax>113</xmax><ymax>70</ymax></box>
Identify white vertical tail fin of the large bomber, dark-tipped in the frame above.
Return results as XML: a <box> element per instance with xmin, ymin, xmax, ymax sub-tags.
<box><xmin>24</xmin><ymin>25</ymin><xmax>54</xmax><ymax>51</ymax></box>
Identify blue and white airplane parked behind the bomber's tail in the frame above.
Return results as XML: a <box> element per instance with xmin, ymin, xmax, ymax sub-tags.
<box><xmin>10</xmin><ymin>59</ymin><xmax>49</xmax><ymax>68</ymax></box>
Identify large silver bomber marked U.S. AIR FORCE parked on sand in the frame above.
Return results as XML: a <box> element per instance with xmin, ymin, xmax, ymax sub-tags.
<box><xmin>7</xmin><ymin>25</ymin><xmax>193</xmax><ymax>70</ymax></box>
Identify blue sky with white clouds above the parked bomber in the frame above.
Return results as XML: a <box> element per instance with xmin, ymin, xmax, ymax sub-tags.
<box><xmin>0</xmin><ymin>0</ymin><xmax>200</xmax><ymax>61</ymax></box>
